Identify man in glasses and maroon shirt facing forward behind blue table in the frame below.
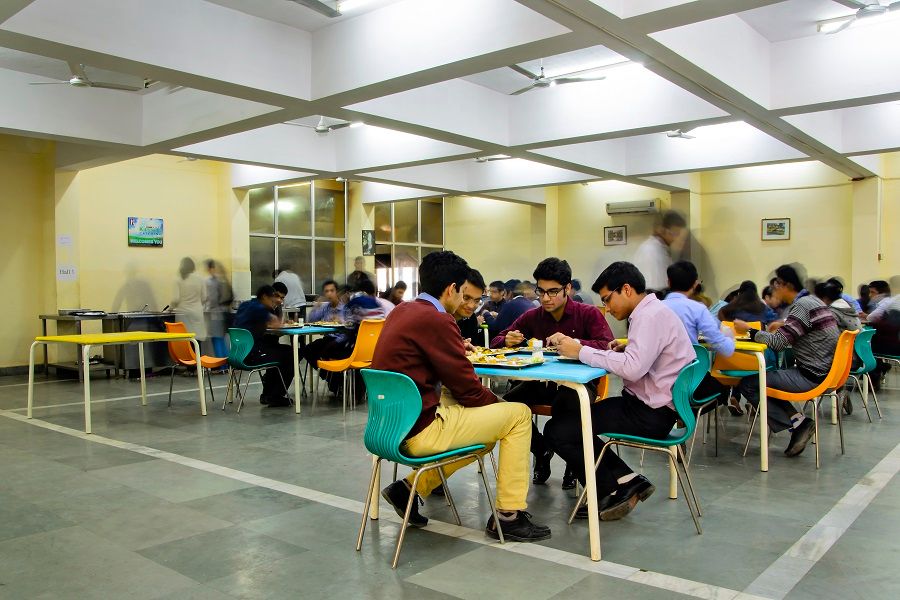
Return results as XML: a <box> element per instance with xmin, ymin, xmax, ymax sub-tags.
<box><xmin>491</xmin><ymin>258</ymin><xmax>613</xmax><ymax>489</ymax></box>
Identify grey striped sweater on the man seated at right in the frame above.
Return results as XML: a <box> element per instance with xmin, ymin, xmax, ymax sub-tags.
<box><xmin>753</xmin><ymin>296</ymin><xmax>840</xmax><ymax>381</ymax></box>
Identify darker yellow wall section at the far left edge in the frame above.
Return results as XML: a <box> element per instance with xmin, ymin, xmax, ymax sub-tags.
<box><xmin>0</xmin><ymin>135</ymin><xmax>55</xmax><ymax>368</ymax></box>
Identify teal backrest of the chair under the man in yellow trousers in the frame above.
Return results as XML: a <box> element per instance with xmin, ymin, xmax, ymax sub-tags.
<box><xmin>360</xmin><ymin>369</ymin><xmax>422</xmax><ymax>464</ymax></box>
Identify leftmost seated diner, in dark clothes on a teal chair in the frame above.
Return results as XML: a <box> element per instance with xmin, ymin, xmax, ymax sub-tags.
<box><xmin>234</xmin><ymin>285</ymin><xmax>294</xmax><ymax>406</ymax></box>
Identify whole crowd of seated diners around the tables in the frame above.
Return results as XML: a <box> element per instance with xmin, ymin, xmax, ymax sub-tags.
<box><xmin>225</xmin><ymin>243</ymin><xmax>900</xmax><ymax>542</ymax></box>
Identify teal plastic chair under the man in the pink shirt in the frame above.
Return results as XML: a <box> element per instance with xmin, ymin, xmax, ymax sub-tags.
<box><xmin>569</xmin><ymin>360</ymin><xmax>703</xmax><ymax>534</ymax></box>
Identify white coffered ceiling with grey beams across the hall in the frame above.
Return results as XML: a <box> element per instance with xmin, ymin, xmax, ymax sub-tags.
<box><xmin>0</xmin><ymin>0</ymin><xmax>900</xmax><ymax>201</ymax></box>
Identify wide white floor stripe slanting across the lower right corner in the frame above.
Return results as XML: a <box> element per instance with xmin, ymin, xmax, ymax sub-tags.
<box><xmin>744</xmin><ymin>444</ymin><xmax>900</xmax><ymax>600</ymax></box>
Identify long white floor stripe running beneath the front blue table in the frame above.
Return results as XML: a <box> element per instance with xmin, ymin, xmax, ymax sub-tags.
<box><xmin>0</xmin><ymin>410</ymin><xmax>771</xmax><ymax>600</ymax></box>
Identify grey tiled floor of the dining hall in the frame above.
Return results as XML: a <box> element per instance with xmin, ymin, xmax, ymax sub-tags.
<box><xmin>0</xmin><ymin>377</ymin><xmax>900</xmax><ymax>600</ymax></box>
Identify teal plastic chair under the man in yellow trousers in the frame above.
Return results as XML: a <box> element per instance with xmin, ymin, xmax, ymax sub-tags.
<box><xmin>356</xmin><ymin>369</ymin><xmax>504</xmax><ymax>569</ymax></box>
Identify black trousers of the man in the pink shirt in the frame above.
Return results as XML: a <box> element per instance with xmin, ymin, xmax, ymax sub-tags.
<box><xmin>544</xmin><ymin>392</ymin><xmax>677</xmax><ymax>497</ymax></box>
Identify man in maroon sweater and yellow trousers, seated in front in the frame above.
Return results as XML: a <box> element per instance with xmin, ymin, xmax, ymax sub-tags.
<box><xmin>370</xmin><ymin>252</ymin><xmax>550</xmax><ymax>542</ymax></box>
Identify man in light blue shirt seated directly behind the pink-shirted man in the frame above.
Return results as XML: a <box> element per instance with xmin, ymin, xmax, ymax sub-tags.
<box><xmin>663</xmin><ymin>260</ymin><xmax>734</xmax><ymax>404</ymax></box>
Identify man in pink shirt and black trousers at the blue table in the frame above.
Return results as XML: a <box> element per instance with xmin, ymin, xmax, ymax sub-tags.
<box><xmin>544</xmin><ymin>262</ymin><xmax>696</xmax><ymax>521</ymax></box>
